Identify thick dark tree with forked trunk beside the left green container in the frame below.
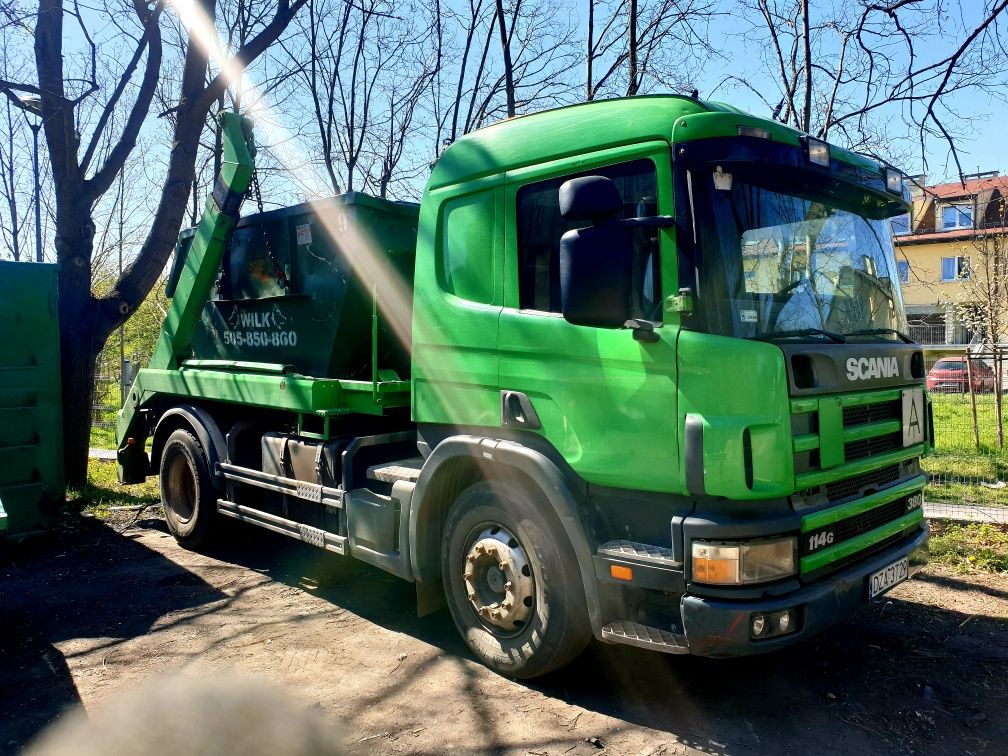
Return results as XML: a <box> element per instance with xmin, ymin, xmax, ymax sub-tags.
<box><xmin>0</xmin><ymin>0</ymin><xmax>305</xmax><ymax>486</ymax></box>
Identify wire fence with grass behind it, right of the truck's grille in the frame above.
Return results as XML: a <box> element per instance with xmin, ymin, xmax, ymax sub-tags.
<box><xmin>924</xmin><ymin>347</ymin><xmax>1008</xmax><ymax>523</ymax></box>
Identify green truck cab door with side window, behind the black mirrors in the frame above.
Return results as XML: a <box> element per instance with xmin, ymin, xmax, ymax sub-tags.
<box><xmin>499</xmin><ymin>142</ymin><xmax>679</xmax><ymax>491</ymax></box>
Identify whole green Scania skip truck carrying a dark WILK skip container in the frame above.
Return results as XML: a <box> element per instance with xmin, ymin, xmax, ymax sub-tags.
<box><xmin>118</xmin><ymin>96</ymin><xmax>933</xmax><ymax>677</ymax></box>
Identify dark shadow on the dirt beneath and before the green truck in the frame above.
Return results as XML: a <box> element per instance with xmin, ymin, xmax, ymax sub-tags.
<box><xmin>192</xmin><ymin>530</ymin><xmax>1008</xmax><ymax>753</ymax></box>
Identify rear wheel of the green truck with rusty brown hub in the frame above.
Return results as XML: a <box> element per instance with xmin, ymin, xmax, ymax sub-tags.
<box><xmin>159</xmin><ymin>428</ymin><xmax>218</xmax><ymax>548</ymax></box>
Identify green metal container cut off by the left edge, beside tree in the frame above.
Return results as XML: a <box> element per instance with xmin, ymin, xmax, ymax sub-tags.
<box><xmin>0</xmin><ymin>261</ymin><xmax>65</xmax><ymax>538</ymax></box>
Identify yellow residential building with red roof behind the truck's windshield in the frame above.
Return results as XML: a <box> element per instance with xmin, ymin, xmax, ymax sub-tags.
<box><xmin>892</xmin><ymin>171</ymin><xmax>1008</xmax><ymax>344</ymax></box>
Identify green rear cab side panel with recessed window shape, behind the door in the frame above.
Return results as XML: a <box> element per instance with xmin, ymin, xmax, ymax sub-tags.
<box><xmin>412</xmin><ymin>175</ymin><xmax>504</xmax><ymax>427</ymax></box>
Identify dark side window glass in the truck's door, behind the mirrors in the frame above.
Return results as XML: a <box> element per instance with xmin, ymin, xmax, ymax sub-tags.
<box><xmin>516</xmin><ymin>160</ymin><xmax>661</xmax><ymax>320</ymax></box>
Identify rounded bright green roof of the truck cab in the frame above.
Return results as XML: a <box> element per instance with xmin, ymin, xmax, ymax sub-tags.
<box><xmin>427</xmin><ymin>95</ymin><xmax>713</xmax><ymax>188</ymax></box>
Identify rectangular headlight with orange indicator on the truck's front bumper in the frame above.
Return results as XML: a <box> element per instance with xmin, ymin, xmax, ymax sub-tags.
<box><xmin>691</xmin><ymin>537</ymin><xmax>796</xmax><ymax>586</ymax></box>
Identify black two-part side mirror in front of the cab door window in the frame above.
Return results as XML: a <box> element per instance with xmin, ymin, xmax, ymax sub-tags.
<box><xmin>559</xmin><ymin>175</ymin><xmax>633</xmax><ymax>329</ymax></box>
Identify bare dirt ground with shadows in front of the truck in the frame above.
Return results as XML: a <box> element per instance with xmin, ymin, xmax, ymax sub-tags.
<box><xmin>0</xmin><ymin>516</ymin><xmax>1008</xmax><ymax>756</ymax></box>
